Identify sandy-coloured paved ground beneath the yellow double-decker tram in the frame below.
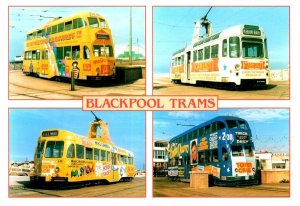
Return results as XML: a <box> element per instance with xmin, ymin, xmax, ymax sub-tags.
<box><xmin>9</xmin><ymin>70</ymin><xmax>146</xmax><ymax>99</ymax></box>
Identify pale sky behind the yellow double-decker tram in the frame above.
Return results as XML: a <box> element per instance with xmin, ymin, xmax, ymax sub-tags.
<box><xmin>9</xmin><ymin>7</ymin><xmax>145</xmax><ymax>60</ymax></box>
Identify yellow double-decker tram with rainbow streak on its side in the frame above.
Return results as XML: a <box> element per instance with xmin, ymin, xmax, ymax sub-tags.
<box><xmin>23</xmin><ymin>12</ymin><xmax>116</xmax><ymax>81</ymax></box>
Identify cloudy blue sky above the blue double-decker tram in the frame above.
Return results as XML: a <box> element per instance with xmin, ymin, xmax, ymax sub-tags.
<box><xmin>153</xmin><ymin>109</ymin><xmax>289</xmax><ymax>153</ymax></box>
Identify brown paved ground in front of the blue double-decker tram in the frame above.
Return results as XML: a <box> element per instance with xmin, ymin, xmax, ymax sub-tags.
<box><xmin>153</xmin><ymin>177</ymin><xmax>290</xmax><ymax>197</ymax></box>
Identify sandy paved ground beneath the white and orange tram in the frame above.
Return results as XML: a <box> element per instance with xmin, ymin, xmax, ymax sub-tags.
<box><xmin>153</xmin><ymin>75</ymin><xmax>290</xmax><ymax>100</ymax></box>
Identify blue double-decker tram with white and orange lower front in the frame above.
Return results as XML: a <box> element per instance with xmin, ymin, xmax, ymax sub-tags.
<box><xmin>168</xmin><ymin>116</ymin><xmax>258</xmax><ymax>185</ymax></box>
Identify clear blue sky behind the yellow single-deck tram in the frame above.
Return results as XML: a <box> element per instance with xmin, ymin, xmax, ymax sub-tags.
<box><xmin>9</xmin><ymin>109</ymin><xmax>145</xmax><ymax>169</ymax></box>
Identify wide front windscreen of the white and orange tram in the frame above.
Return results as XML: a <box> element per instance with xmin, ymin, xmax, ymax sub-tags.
<box><xmin>242</xmin><ymin>42</ymin><xmax>264</xmax><ymax>58</ymax></box>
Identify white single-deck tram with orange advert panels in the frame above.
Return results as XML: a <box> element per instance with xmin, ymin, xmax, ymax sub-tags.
<box><xmin>170</xmin><ymin>11</ymin><xmax>270</xmax><ymax>88</ymax></box>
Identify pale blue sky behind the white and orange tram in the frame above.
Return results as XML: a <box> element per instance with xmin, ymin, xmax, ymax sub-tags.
<box><xmin>153</xmin><ymin>7</ymin><xmax>289</xmax><ymax>73</ymax></box>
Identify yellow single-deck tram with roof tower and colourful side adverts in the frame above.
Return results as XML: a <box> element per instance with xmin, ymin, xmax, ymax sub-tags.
<box><xmin>30</xmin><ymin>112</ymin><xmax>135</xmax><ymax>186</ymax></box>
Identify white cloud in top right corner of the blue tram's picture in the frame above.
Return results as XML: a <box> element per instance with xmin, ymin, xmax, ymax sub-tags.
<box><xmin>236</xmin><ymin>109</ymin><xmax>289</xmax><ymax>122</ymax></box>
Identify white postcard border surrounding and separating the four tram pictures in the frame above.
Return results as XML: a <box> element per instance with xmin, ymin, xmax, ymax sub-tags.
<box><xmin>0</xmin><ymin>0</ymin><xmax>300</xmax><ymax>206</ymax></box>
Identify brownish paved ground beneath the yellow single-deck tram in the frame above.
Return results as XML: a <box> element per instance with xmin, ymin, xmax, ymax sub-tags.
<box><xmin>9</xmin><ymin>176</ymin><xmax>146</xmax><ymax>197</ymax></box>
